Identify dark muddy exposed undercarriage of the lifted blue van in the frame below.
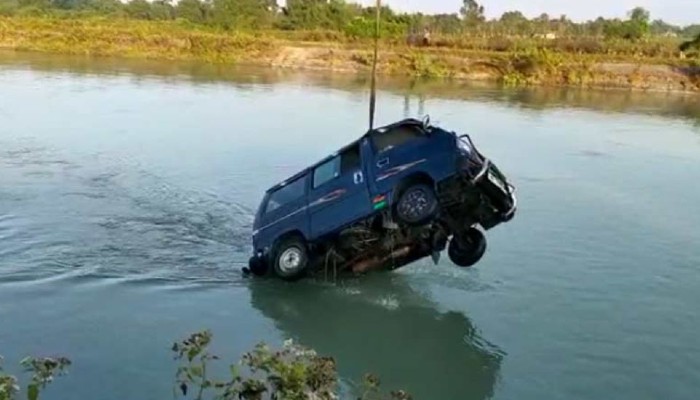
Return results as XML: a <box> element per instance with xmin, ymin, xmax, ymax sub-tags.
<box><xmin>306</xmin><ymin>164</ymin><xmax>508</xmax><ymax>274</ymax></box>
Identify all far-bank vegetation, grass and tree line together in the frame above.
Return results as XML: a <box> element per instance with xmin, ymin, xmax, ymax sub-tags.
<box><xmin>0</xmin><ymin>0</ymin><xmax>700</xmax><ymax>91</ymax></box>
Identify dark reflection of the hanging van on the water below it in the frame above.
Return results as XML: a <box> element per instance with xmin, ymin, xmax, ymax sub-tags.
<box><xmin>249</xmin><ymin>274</ymin><xmax>505</xmax><ymax>399</ymax></box>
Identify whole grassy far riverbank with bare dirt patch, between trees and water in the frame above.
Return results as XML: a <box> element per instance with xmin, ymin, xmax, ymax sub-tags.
<box><xmin>0</xmin><ymin>17</ymin><xmax>700</xmax><ymax>92</ymax></box>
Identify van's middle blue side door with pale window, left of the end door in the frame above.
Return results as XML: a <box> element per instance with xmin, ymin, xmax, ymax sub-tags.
<box><xmin>309</xmin><ymin>143</ymin><xmax>372</xmax><ymax>238</ymax></box>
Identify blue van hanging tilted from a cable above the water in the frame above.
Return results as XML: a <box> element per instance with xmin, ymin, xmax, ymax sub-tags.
<box><xmin>249</xmin><ymin>118</ymin><xmax>517</xmax><ymax>280</ymax></box>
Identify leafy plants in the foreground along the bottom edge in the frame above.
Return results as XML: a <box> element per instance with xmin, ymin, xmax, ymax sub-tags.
<box><xmin>0</xmin><ymin>330</ymin><xmax>411</xmax><ymax>400</ymax></box>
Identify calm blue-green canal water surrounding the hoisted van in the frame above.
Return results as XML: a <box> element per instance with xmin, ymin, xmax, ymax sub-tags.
<box><xmin>0</xmin><ymin>53</ymin><xmax>700</xmax><ymax>400</ymax></box>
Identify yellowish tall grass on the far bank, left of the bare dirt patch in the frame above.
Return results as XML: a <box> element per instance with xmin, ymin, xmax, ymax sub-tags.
<box><xmin>0</xmin><ymin>17</ymin><xmax>275</xmax><ymax>62</ymax></box>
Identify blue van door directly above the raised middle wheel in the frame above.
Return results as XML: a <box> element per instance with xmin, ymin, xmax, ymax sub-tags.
<box><xmin>371</xmin><ymin>125</ymin><xmax>435</xmax><ymax>193</ymax></box>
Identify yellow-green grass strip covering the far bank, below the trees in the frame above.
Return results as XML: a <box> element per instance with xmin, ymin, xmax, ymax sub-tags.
<box><xmin>0</xmin><ymin>14</ymin><xmax>698</xmax><ymax>91</ymax></box>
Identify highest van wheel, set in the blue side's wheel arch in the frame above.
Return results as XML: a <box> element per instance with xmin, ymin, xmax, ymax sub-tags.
<box><xmin>394</xmin><ymin>184</ymin><xmax>438</xmax><ymax>226</ymax></box>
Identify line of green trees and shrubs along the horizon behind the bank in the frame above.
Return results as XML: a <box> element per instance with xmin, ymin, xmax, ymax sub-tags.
<box><xmin>0</xmin><ymin>0</ymin><xmax>700</xmax><ymax>44</ymax></box>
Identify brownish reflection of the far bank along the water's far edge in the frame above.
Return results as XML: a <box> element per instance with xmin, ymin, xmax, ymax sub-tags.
<box><xmin>0</xmin><ymin>51</ymin><xmax>700</xmax><ymax>125</ymax></box>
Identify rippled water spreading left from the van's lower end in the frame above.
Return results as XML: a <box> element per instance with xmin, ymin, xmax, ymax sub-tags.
<box><xmin>0</xmin><ymin>140</ymin><xmax>253</xmax><ymax>284</ymax></box>
